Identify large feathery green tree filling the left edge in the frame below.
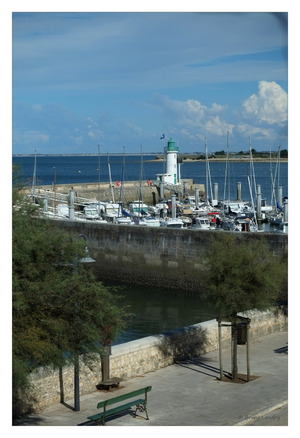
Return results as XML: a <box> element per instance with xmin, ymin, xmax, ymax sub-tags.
<box><xmin>12</xmin><ymin>175</ymin><xmax>126</xmax><ymax>414</ymax></box>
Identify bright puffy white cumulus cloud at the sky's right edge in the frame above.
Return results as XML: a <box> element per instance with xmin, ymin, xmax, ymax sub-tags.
<box><xmin>243</xmin><ymin>81</ymin><xmax>288</xmax><ymax>125</ymax></box>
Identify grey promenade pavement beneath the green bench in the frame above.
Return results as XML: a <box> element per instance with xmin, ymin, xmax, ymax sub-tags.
<box><xmin>14</xmin><ymin>332</ymin><xmax>288</xmax><ymax>427</ymax></box>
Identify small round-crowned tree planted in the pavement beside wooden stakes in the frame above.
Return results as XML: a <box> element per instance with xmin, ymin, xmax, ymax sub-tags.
<box><xmin>204</xmin><ymin>233</ymin><xmax>287</xmax><ymax>379</ymax></box>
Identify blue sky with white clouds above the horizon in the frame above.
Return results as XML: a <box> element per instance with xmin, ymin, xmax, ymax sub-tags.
<box><xmin>12</xmin><ymin>12</ymin><xmax>288</xmax><ymax>154</ymax></box>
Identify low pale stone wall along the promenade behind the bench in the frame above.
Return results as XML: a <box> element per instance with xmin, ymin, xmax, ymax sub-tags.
<box><xmin>31</xmin><ymin>309</ymin><xmax>288</xmax><ymax>412</ymax></box>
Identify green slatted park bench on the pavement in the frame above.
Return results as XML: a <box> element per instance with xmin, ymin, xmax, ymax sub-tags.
<box><xmin>87</xmin><ymin>386</ymin><xmax>152</xmax><ymax>426</ymax></box>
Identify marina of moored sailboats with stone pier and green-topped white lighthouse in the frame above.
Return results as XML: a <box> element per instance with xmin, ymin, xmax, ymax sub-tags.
<box><xmin>19</xmin><ymin>139</ymin><xmax>288</xmax><ymax>233</ymax></box>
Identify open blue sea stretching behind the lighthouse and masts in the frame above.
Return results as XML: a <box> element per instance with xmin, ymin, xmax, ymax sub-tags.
<box><xmin>13</xmin><ymin>155</ymin><xmax>288</xmax><ymax>204</ymax></box>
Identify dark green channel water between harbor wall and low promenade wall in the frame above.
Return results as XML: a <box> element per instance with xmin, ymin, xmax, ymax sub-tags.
<box><xmin>109</xmin><ymin>286</ymin><xmax>216</xmax><ymax>344</ymax></box>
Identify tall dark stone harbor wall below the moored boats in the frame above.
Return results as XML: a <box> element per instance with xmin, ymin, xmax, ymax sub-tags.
<box><xmin>58</xmin><ymin>221</ymin><xmax>288</xmax><ymax>292</ymax></box>
